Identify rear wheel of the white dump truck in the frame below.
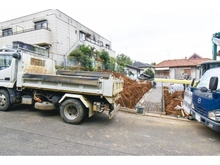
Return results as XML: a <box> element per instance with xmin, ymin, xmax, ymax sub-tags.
<box><xmin>60</xmin><ymin>99</ymin><xmax>85</xmax><ymax>124</ymax></box>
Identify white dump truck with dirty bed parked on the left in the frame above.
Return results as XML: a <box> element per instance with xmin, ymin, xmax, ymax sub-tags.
<box><xmin>0</xmin><ymin>43</ymin><xmax>124</xmax><ymax>124</ymax></box>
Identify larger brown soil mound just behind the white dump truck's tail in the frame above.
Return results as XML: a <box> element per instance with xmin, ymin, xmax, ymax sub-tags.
<box><xmin>113</xmin><ymin>73</ymin><xmax>152</xmax><ymax>109</ymax></box>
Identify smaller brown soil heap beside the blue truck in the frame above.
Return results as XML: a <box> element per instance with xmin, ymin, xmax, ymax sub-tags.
<box><xmin>164</xmin><ymin>87</ymin><xmax>187</xmax><ymax>117</ymax></box>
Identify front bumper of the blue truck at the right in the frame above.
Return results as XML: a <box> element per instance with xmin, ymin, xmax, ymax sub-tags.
<box><xmin>191</xmin><ymin>109</ymin><xmax>220</xmax><ymax>132</ymax></box>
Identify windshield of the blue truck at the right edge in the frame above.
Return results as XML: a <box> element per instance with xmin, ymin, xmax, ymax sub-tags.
<box><xmin>197</xmin><ymin>68</ymin><xmax>220</xmax><ymax>90</ymax></box>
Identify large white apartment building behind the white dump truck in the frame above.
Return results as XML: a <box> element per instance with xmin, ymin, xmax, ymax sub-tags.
<box><xmin>0</xmin><ymin>9</ymin><xmax>116</xmax><ymax>65</ymax></box>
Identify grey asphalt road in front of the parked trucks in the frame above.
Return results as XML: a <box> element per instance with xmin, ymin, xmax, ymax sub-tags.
<box><xmin>0</xmin><ymin>107</ymin><xmax>220</xmax><ymax>156</ymax></box>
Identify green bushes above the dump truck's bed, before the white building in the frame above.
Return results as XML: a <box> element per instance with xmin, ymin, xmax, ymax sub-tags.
<box><xmin>67</xmin><ymin>45</ymin><xmax>135</xmax><ymax>74</ymax></box>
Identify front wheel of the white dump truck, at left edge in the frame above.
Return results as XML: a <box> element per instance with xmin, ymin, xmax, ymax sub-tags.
<box><xmin>0</xmin><ymin>89</ymin><xmax>10</xmax><ymax>111</ymax></box>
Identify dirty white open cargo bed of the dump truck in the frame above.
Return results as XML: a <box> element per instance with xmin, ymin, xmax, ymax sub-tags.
<box><xmin>21</xmin><ymin>71</ymin><xmax>123</xmax><ymax>98</ymax></box>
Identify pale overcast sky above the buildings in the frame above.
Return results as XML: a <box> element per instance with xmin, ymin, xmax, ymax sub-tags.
<box><xmin>0</xmin><ymin>0</ymin><xmax>220</xmax><ymax>63</ymax></box>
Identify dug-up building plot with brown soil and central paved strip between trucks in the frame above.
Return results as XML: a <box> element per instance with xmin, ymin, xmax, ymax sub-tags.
<box><xmin>111</xmin><ymin>73</ymin><xmax>187</xmax><ymax>118</ymax></box>
